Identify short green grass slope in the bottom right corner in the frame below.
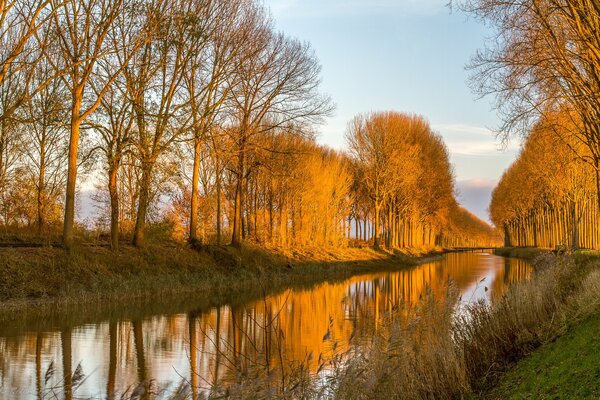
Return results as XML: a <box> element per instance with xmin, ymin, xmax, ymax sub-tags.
<box><xmin>484</xmin><ymin>312</ymin><xmax>600</xmax><ymax>399</ymax></box>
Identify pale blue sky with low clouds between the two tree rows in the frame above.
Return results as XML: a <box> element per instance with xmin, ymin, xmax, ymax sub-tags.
<box><xmin>265</xmin><ymin>0</ymin><xmax>519</xmax><ymax>221</ymax></box>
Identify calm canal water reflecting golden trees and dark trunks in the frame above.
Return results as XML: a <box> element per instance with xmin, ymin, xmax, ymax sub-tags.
<box><xmin>0</xmin><ymin>253</ymin><xmax>531</xmax><ymax>400</ymax></box>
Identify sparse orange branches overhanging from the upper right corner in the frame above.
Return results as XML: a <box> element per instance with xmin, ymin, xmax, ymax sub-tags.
<box><xmin>455</xmin><ymin>0</ymin><xmax>600</xmax><ymax>208</ymax></box>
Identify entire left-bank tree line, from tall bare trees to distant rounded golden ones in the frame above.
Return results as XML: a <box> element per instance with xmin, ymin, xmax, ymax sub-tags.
<box><xmin>0</xmin><ymin>0</ymin><xmax>492</xmax><ymax>250</ymax></box>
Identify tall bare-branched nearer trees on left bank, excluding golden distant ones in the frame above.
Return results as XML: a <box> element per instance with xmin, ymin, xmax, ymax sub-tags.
<box><xmin>0</xmin><ymin>0</ymin><xmax>332</xmax><ymax>248</ymax></box>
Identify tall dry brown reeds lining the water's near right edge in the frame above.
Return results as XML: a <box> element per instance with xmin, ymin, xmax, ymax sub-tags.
<box><xmin>207</xmin><ymin>254</ymin><xmax>600</xmax><ymax>399</ymax></box>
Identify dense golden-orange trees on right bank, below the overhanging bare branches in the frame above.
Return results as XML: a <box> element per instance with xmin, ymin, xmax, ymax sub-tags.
<box><xmin>490</xmin><ymin>112</ymin><xmax>600</xmax><ymax>249</ymax></box>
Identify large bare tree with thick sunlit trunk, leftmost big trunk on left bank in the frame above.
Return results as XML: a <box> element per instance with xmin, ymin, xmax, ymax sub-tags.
<box><xmin>43</xmin><ymin>0</ymin><xmax>138</xmax><ymax>249</ymax></box>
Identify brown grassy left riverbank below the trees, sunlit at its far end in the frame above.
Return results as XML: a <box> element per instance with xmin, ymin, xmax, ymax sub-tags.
<box><xmin>0</xmin><ymin>243</ymin><xmax>440</xmax><ymax>312</ymax></box>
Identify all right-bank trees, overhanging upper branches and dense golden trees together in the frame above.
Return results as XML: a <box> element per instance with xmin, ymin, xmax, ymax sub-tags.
<box><xmin>456</xmin><ymin>0</ymin><xmax>600</xmax><ymax>248</ymax></box>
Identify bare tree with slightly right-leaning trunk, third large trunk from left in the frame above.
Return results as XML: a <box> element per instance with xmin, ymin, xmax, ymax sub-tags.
<box><xmin>124</xmin><ymin>0</ymin><xmax>205</xmax><ymax>246</ymax></box>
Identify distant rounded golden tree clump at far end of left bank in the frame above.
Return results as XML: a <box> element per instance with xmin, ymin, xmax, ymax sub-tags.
<box><xmin>346</xmin><ymin>112</ymin><xmax>496</xmax><ymax>248</ymax></box>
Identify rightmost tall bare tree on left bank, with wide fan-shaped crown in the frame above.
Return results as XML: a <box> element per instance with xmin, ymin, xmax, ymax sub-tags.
<box><xmin>228</xmin><ymin>19</ymin><xmax>333</xmax><ymax>246</ymax></box>
